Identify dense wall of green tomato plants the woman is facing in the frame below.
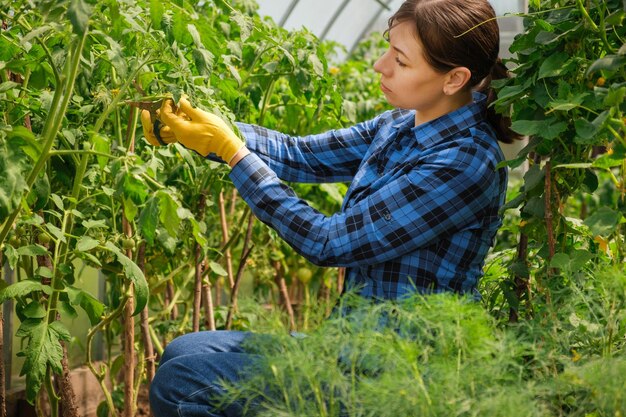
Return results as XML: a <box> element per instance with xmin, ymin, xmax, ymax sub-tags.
<box><xmin>0</xmin><ymin>0</ymin><xmax>366</xmax><ymax>415</ymax></box>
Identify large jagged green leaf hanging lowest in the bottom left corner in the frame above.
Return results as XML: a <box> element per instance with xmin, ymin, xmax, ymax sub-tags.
<box><xmin>15</xmin><ymin>319</ymin><xmax>71</xmax><ymax>404</ymax></box>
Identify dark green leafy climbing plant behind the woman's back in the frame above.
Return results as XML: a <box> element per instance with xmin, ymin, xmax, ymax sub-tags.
<box><xmin>496</xmin><ymin>0</ymin><xmax>626</xmax><ymax>317</ymax></box>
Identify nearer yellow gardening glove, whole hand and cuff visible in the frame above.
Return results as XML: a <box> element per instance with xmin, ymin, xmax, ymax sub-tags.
<box><xmin>160</xmin><ymin>97</ymin><xmax>244</xmax><ymax>162</ymax></box>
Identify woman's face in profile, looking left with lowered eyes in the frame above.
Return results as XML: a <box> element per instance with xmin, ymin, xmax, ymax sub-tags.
<box><xmin>374</xmin><ymin>22</ymin><xmax>446</xmax><ymax>122</ymax></box>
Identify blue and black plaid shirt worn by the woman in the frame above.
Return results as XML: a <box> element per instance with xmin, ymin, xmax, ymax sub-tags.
<box><xmin>230</xmin><ymin>94</ymin><xmax>507</xmax><ymax>299</ymax></box>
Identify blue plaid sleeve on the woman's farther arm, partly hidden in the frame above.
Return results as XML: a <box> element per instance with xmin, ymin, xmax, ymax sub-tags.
<box><xmin>237</xmin><ymin>116</ymin><xmax>380</xmax><ymax>183</ymax></box>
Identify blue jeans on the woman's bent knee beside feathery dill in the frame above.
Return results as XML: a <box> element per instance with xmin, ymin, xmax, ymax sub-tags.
<box><xmin>150</xmin><ymin>331</ymin><xmax>255</xmax><ymax>417</ymax></box>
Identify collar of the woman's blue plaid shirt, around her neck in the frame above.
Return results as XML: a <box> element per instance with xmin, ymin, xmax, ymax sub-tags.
<box><xmin>392</xmin><ymin>92</ymin><xmax>487</xmax><ymax>148</ymax></box>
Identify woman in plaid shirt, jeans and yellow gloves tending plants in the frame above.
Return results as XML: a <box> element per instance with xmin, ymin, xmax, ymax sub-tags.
<box><xmin>142</xmin><ymin>0</ymin><xmax>514</xmax><ymax>417</ymax></box>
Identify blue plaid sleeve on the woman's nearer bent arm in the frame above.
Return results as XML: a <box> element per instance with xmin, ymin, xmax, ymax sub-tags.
<box><xmin>230</xmin><ymin>141</ymin><xmax>499</xmax><ymax>267</ymax></box>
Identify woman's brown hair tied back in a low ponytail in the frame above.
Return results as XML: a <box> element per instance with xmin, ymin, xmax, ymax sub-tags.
<box><xmin>387</xmin><ymin>0</ymin><xmax>519</xmax><ymax>143</ymax></box>
